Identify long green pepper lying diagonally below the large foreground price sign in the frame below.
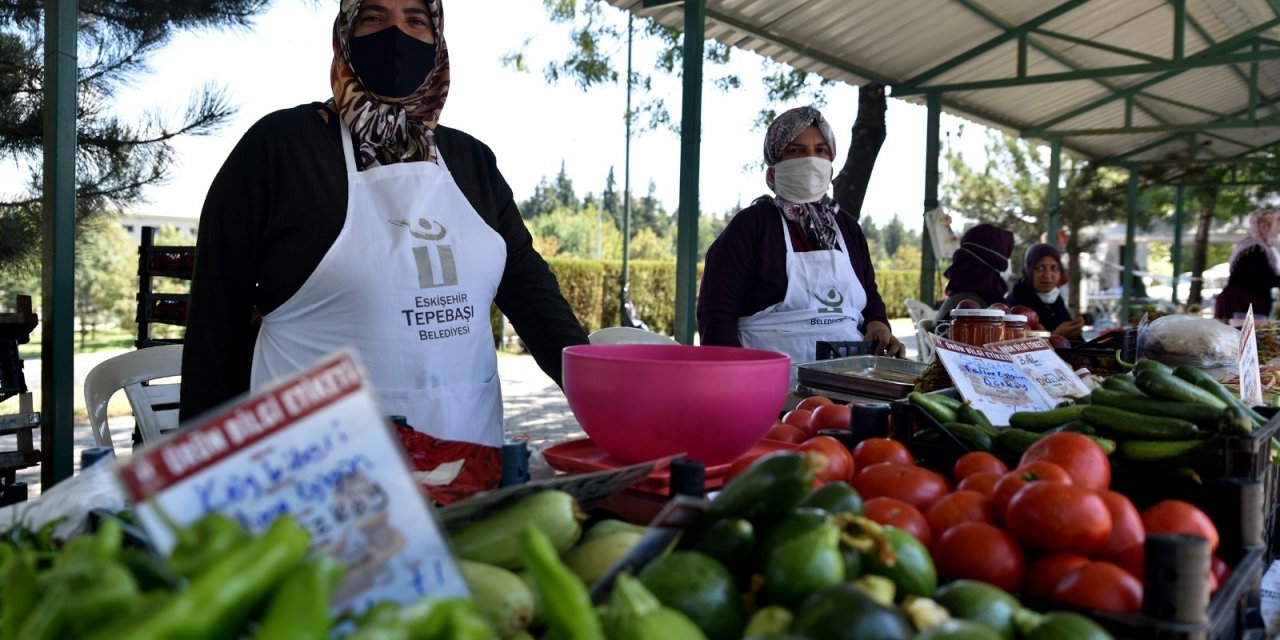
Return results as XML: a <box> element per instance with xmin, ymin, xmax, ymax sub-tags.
<box><xmin>91</xmin><ymin>516</ymin><xmax>311</xmax><ymax>640</ymax></box>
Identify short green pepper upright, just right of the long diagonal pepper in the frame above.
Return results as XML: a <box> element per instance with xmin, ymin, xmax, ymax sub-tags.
<box><xmin>253</xmin><ymin>556</ymin><xmax>347</xmax><ymax>640</ymax></box>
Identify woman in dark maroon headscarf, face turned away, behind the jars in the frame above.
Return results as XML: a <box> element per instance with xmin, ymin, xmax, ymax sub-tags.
<box><xmin>937</xmin><ymin>224</ymin><xmax>1014</xmax><ymax>321</ymax></box>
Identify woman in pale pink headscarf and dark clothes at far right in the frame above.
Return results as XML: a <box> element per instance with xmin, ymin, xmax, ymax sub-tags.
<box><xmin>1213</xmin><ymin>209</ymin><xmax>1280</xmax><ymax>323</ymax></box>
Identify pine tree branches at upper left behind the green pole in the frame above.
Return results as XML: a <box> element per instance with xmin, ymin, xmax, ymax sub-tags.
<box><xmin>0</xmin><ymin>0</ymin><xmax>269</xmax><ymax>271</ymax></box>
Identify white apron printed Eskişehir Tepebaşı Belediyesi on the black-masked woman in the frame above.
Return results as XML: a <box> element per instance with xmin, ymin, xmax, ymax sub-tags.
<box><xmin>251</xmin><ymin>123</ymin><xmax>507</xmax><ymax>447</ymax></box>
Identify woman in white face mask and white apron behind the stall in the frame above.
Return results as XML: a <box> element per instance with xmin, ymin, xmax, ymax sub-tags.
<box><xmin>698</xmin><ymin>106</ymin><xmax>904</xmax><ymax>371</ymax></box>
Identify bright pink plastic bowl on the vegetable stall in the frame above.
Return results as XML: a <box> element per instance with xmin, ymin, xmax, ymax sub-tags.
<box><xmin>563</xmin><ymin>344</ymin><xmax>791</xmax><ymax>465</ymax></box>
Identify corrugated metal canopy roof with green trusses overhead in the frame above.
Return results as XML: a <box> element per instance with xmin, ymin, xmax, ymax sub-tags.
<box><xmin>608</xmin><ymin>0</ymin><xmax>1280</xmax><ymax>165</ymax></box>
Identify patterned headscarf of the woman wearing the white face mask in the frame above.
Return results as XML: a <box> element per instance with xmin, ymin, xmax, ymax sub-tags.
<box><xmin>764</xmin><ymin>106</ymin><xmax>840</xmax><ymax>251</ymax></box>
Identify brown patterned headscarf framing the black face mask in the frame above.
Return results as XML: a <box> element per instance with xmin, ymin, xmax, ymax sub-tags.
<box><xmin>328</xmin><ymin>0</ymin><xmax>449</xmax><ymax>170</ymax></box>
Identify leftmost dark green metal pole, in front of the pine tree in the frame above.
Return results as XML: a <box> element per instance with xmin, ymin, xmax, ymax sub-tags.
<box><xmin>40</xmin><ymin>0</ymin><xmax>78</xmax><ymax>483</ymax></box>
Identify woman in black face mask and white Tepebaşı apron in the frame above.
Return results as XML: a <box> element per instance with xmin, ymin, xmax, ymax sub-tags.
<box><xmin>180</xmin><ymin>0</ymin><xmax>588</xmax><ymax>499</ymax></box>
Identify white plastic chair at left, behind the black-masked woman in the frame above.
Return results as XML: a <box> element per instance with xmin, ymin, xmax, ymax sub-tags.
<box><xmin>84</xmin><ymin>344</ymin><xmax>182</xmax><ymax>447</ymax></box>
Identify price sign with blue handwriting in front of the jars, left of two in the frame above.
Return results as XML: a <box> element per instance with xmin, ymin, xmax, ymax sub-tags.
<box><xmin>934</xmin><ymin>338</ymin><xmax>1055</xmax><ymax>425</ymax></box>
